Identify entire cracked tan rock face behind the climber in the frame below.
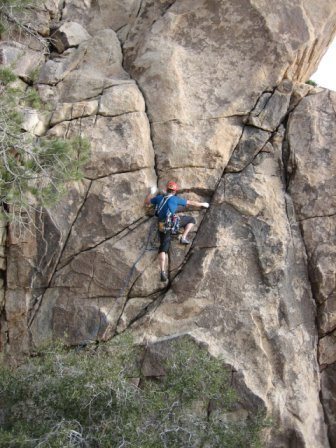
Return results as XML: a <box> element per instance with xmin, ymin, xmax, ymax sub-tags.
<box><xmin>0</xmin><ymin>0</ymin><xmax>336</xmax><ymax>448</ymax></box>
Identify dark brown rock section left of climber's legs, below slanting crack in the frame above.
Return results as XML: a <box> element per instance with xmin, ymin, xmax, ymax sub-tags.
<box><xmin>29</xmin><ymin>222</ymin><xmax>156</xmax><ymax>345</ymax></box>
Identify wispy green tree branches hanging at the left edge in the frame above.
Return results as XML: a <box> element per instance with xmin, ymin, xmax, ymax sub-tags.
<box><xmin>0</xmin><ymin>69</ymin><xmax>89</xmax><ymax>225</ymax></box>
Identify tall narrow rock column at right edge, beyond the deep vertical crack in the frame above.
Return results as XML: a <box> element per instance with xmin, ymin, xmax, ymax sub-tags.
<box><xmin>287</xmin><ymin>91</ymin><xmax>336</xmax><ymax>344</ymax></box>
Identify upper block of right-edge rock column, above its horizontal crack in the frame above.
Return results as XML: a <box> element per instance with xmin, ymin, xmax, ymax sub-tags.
<box><xmin>288</xmin><ymin>90</ymin><xmax>336</xmax><ymax>220</ymax></box>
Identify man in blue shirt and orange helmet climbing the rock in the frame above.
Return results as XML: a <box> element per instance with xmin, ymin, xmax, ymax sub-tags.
<box><xmin>145</xmin><ymin>181</ymin><xmax>209</xmax><ymax>282</ymax></box>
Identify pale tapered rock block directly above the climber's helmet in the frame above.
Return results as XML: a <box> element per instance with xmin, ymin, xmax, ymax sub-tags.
<box><xmin>151</xmin><ymin>118</ymin><xmax>242</xmax><ymax>191</ymax></box>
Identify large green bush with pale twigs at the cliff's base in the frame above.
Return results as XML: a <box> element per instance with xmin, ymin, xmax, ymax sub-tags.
<box><xmin>0</xmin><ymin>336</ymin><xmax>265</xmax><ymax>448</ymax></box>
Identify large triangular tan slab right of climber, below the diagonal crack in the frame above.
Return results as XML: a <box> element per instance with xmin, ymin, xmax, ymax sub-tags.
<box><xmin>131</xmin><ymin>145</ymin><xmax>327</xmax><ymax>447</ymax></box>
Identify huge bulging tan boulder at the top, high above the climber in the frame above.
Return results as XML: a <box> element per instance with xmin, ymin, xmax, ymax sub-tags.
<box><xmin>124</xmin><ymin>0</ymin><xmax>336</xmax><ymax>121</ymax></box>
